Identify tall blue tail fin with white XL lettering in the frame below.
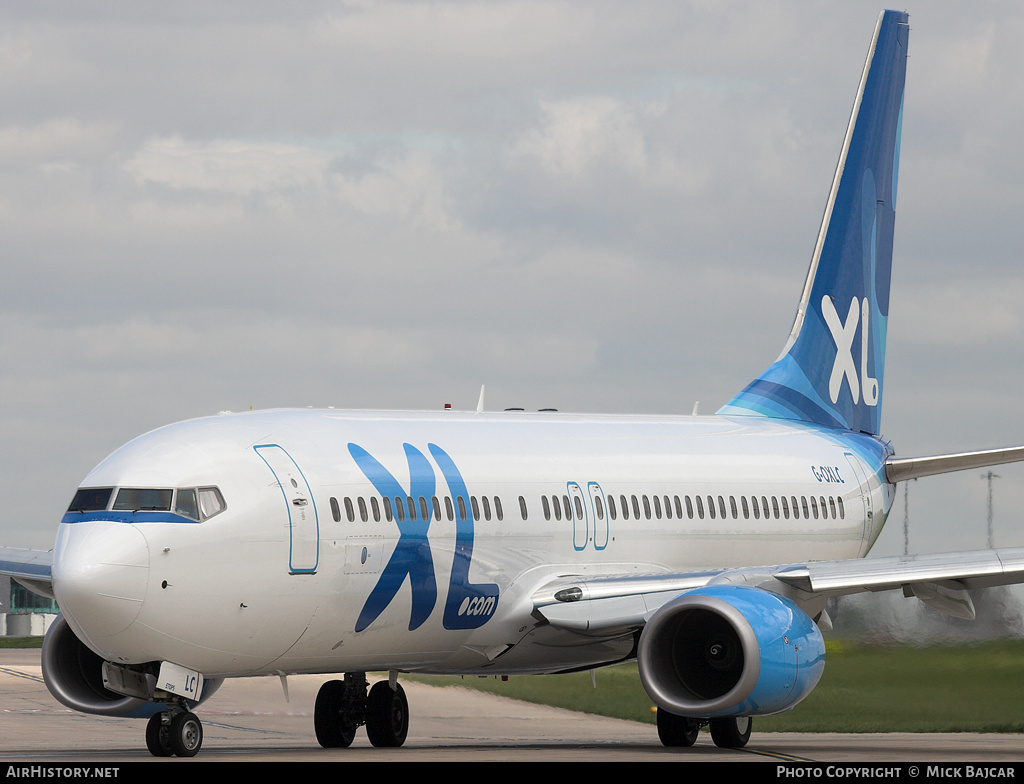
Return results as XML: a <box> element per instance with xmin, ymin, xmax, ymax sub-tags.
<box><xmin>719</xmin><ymin>11</ymin><xmax>908</xmax><ymax>435</ymax></box>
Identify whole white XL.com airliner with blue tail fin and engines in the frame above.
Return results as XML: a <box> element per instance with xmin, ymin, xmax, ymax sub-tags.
<box><xmin>0</xmin><ymin>11</ymin><xmax>1024</xmax><ymax>756</ymax></box>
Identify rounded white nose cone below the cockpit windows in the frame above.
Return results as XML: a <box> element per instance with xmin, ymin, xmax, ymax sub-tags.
<box><xmin>52</xmin><ymin>521</ymin><xmax>150</xmax><ymax>639</ymax></box>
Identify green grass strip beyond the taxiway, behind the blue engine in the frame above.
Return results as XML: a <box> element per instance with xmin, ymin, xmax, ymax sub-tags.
<box><xmin>405</xmin><ymin>641</ymin><xmax>1024</xmax><ymax>733</ymax></box>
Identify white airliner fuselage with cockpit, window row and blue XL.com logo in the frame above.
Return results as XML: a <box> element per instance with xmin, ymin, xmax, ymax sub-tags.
<box><xmin>53</xmin><ymin>409</ymin><xmax>892</xmax><ymax>677</ymax></box>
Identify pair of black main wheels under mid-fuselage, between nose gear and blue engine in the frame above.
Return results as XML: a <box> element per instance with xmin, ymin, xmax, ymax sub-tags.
<box><xmin>313</xmin><ymin>672</ymin><xmax>409</xmax><ymax>748</ymax></box>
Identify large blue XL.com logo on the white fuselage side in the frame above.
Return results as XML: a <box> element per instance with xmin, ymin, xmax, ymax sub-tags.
<box><xmin>348</xmin><ymin>443</ymin><xmax>498</xmax><ymax>631</ymax></box>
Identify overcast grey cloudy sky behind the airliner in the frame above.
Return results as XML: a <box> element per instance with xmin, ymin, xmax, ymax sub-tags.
<box><xmin>0</xmin><ymin>0</ymin><xmax>1024</xmax><ymax>554</ymax></box>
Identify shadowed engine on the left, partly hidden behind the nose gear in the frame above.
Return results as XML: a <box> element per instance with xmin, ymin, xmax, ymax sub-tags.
<box><xmin>42</xmin><ymin>615</ymin><xmax>220</xmax><ymax>716</ymax></box>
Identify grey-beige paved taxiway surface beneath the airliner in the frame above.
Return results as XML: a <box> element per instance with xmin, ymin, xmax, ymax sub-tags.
<box><xmin>0</xmin><ymin>650</ymin><xmax>1024</xmax><ymax>766</ymax></box>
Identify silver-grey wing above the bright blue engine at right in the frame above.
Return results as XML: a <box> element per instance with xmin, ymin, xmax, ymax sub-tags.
<box><xmin>534</xmin><ymin>548</ymin><xmax>1024</xmax><ymax>635</ymax></box>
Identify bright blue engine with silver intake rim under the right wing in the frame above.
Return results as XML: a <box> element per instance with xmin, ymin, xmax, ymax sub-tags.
<box><xmin>637</xmin><ymin>585</ymin><xmax>825</xmax><ymax>718</ymax></box>
